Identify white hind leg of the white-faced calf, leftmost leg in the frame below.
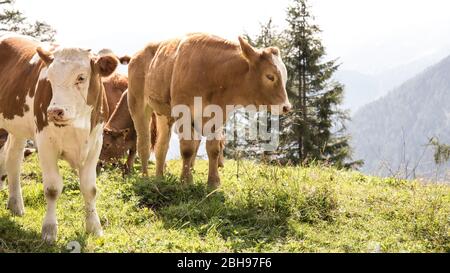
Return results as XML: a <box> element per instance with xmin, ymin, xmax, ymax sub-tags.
<box><xmin>5</xmin><ymin>134</ymin><xmax>26</xmax><ymax>216</ymax></box>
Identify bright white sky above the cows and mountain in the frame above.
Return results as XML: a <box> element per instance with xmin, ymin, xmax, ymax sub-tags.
<box><xmin>16</xmin><ymin>0</ymin><xmax>450</xmax><ymax>73</ymax></box>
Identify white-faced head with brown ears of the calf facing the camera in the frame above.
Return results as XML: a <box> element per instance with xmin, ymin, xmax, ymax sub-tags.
<box><xmin>37</xmin><ymin>48</ymin><xmax>119</xmax><ymax>126</ymax></box>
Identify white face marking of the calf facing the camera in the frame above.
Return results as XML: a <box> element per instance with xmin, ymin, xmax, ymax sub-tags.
<box><xmin>46</xmin><ymin>48</ymin><xmax>92</xmax><ymax>127</ymax></box>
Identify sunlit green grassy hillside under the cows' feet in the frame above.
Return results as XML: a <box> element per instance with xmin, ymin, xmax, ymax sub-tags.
<box><xmin>0</xmin><ymin>154</ymin><xmax>450</xmax><ymax>252</ymax></box>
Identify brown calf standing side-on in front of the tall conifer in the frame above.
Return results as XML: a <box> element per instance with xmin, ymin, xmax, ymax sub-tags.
<box><xmin>128</xmin><ymin>33</ymin><xmax>291</xmax><ymax>188</ymax></box>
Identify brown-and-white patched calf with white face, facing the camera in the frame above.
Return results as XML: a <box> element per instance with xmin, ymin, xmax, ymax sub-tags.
<box><xmin>0</xmin><ymin>34</ymin><xmax>125</xmax><ymax>242</ymax></box>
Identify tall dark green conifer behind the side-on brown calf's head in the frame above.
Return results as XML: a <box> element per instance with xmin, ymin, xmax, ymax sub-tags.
<box><xmin>228</xmin><ymin>0</ymin><xmax>363</xmax><ymax>168</ymax></box>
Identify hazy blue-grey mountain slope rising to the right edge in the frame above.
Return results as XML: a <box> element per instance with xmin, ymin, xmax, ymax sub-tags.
<box><xmin>349</xmin><ymin>56</ymin><xmax>450</xmax><ymax>178</ymax></box>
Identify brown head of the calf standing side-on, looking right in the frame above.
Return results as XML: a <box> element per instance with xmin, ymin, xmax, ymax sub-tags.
<box><xmin>239</xmin><ymin>37</ymin><xmax>292</xmax><ymax>114</ymax></box>
